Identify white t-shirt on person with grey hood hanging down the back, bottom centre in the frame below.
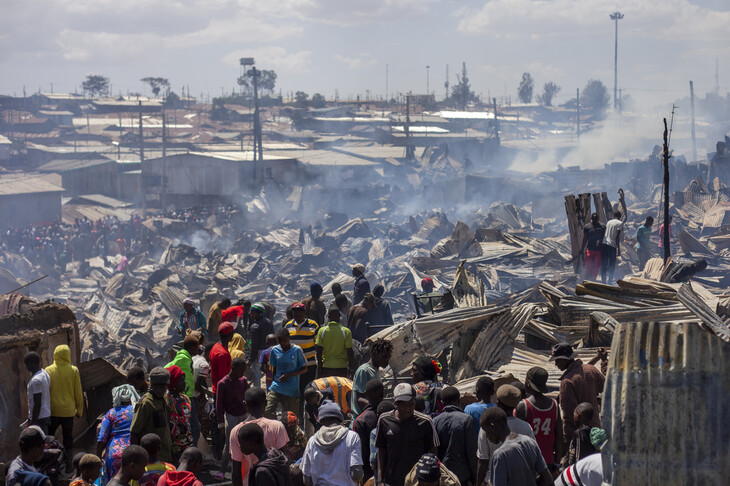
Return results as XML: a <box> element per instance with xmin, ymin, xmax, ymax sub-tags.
<box><xmin>300</xmin><ymin>430</ymin><xmax>362</xmax><ymax>486</ymax></box>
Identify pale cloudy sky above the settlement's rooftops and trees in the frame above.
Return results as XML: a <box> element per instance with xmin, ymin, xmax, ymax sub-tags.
<box><xmin>0</xmin><ymin>0</ymin><xmax>730</xmax><ymax>106</ymax></box>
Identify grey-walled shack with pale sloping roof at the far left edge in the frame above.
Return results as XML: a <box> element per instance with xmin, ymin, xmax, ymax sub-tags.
<box><xmin>0</xmin><ymin>174</ymin><xmax>63</xmax><ymax>229</ymax></box>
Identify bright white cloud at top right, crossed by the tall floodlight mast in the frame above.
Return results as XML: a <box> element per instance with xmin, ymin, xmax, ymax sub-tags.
<box><xmin>458</xmin><ymin>0</ymin><xmax>730</xmax><ymax>41</ymax></box>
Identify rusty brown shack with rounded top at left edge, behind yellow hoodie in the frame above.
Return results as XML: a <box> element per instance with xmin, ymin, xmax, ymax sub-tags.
<box><xmin>0</xmin><ymin>293</ymin><xmax>81</xmax><ymax>461</ymax></box>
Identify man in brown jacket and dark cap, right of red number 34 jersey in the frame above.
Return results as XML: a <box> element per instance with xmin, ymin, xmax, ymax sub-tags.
<box><xmin>550</xmin><ymin>342</ymin><xmax>606</xmax><ymax>450</ymax></box>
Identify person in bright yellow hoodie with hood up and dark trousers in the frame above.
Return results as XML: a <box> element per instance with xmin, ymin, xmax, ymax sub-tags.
<box><xmin>46</xmin><ymin>344</ymin><xmax>84</xmax><ymax>469</ymax></box>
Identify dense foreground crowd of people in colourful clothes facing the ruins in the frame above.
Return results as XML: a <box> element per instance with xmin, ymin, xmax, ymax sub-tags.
<box><xmin>12</xmin><ymin>265</ymin><xmax>606</xmax><ymax>486</ymax></box>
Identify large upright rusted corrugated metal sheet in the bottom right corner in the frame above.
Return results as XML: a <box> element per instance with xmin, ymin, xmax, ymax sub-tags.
<box><xmin>602</xmin><ymin>323</ymin><xmax>730</xmax><ymax>486</ymax></box>
